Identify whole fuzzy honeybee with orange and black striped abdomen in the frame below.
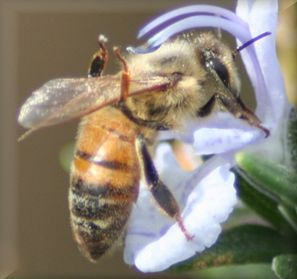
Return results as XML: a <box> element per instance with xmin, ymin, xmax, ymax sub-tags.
<box><xmin>18</xmin><ymin>33</ymin><xmax>269</xmax><ymax>261</ymax></box>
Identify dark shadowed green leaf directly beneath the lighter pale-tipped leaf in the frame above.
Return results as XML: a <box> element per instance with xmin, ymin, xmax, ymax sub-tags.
<box><xmin>235</xmin><ymin>175</ymin><xmax>294</xmax><ymax>234</ymax></box>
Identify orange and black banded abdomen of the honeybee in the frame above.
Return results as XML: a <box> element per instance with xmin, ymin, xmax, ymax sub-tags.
<box><xmin>69</xmin><ymin>107</ymin><xmax>140</xmax><ymax>261</ymax></box>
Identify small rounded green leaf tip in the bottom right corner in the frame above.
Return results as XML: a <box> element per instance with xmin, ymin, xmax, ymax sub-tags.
<box><xmin>272</xmin><ymin>254</ymin><xmax>297</xmax><ymax>279</ymax></box>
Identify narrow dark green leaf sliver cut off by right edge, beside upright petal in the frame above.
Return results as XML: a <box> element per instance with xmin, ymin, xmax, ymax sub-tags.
<box><xmin>287</xmin><ymin>107</ymin><xmax>297</xmax><ymax>170</ymax></box>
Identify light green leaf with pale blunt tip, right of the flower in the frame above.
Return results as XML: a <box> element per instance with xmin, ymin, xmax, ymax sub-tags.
<box><xmin>236</xmin><ymin>153</ymin><xmax>297</xmax><ymax>208</ymax></box>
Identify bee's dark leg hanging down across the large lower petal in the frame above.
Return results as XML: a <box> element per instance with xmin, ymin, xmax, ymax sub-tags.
<box><xmin>140</xmin><ymin>139</ymin><xmax>194</xmax><ymax>241</ymax></box>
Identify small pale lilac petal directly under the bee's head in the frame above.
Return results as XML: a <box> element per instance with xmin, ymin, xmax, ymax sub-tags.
<box><xmin>159</xmin><ymin>112</ymin><xmax>265</xmax><ymax>155</ymax></box>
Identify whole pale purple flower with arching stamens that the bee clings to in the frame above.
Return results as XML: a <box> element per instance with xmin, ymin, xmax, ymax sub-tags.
<box><xmin>124</xmin><ymin>0</ymin><xmax>285</xmax><ymax>272</ymax></box>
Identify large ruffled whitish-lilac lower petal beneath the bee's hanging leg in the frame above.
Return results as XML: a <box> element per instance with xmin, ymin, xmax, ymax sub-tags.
<box><xmin>124</xmin><ymin>144</ymin><xmax>236</xmax><ymax>272</ymax></box>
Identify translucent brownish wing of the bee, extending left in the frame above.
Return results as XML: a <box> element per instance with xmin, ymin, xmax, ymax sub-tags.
<box><xmin>18</xmin><ymin>75</ymin><xmax>170</xmax><ymax>130</ymax></box>
